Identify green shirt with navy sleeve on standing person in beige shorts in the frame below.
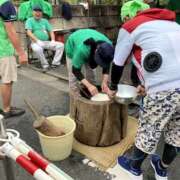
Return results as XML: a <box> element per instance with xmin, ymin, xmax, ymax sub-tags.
<box><xmin>0</xmin><ymin>0</ymin><xmax>16</xmax><ymax>58</ymax></box>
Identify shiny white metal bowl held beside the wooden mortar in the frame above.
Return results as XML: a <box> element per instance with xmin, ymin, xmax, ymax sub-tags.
<box><xmin>115</xmin><ymin>84</ymin><xmax>137</xmax><ymax>104</ymax></box>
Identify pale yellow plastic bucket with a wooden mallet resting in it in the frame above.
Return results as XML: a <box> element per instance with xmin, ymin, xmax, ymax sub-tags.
<box><xmin>37</xmin><ymin>116</ymin><xmax>76</xmax><ymax>161</ymax></box>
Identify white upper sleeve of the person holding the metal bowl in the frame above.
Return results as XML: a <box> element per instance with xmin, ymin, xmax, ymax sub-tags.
<box><xmin>113</xmin><ymin>28</ymin><xmax>134</xmax><ymax>66</ymax></box>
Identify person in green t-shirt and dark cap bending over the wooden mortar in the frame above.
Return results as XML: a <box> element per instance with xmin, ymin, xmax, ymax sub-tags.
<box><xmin>65</xmin><ymin>29</ymin><xmax>114</xmax><ymax>96</ymax></box>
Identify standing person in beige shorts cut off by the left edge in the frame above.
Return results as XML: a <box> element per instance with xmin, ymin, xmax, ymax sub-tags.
<box><xmin>0</xmin><ymin>0</ymin><xmax>27</xmax><ymax>118</ymax></box>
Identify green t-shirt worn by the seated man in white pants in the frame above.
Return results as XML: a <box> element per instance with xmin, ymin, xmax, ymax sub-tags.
<box><xmin>25</xmin><ymin>17</ymin><xmax>52</xmax><ymax>41</ymax></box>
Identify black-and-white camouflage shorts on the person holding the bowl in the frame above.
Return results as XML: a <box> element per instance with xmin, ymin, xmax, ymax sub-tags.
<box><xmin>135</xmin><ymin>89</ymin><xmax>180</xmax><ymax>154</ymax></box>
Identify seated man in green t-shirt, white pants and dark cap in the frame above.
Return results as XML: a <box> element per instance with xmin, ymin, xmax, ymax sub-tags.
<box><xmin>25</xmin><ymin>5</ymin><xmax>64</xmax><ymax>72</ymax></box>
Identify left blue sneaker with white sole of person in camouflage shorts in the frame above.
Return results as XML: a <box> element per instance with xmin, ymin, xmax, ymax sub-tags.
<box><xmin>118</xmin><ymin>156</ymin><xmax>143</xmax><ymax>180</ymax></box>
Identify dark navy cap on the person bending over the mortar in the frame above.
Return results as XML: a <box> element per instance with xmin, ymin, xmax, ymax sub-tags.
<box><xmin>94</xmin><ymin>42</ymin><xmax>114</xmax><ymax>68</ymax></box>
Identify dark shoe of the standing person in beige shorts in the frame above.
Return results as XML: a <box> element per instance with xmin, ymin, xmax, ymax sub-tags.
<box><xmin>0</xmin><ymin>107</ymin><xmax>25</xmax><ymax>119</ymax></box>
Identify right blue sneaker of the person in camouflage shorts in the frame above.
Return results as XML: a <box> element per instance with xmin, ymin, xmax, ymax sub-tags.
<box><xmin>151</xmin><ymin>155</ymin><xmax>168</xmax><ymax>180</ymax></box>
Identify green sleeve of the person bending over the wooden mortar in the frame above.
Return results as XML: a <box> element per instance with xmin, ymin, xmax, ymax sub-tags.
<box><xmin>72</xmin><ymin>46</ymin><xmax>90</xmax><ymax>69</ymax></box>
